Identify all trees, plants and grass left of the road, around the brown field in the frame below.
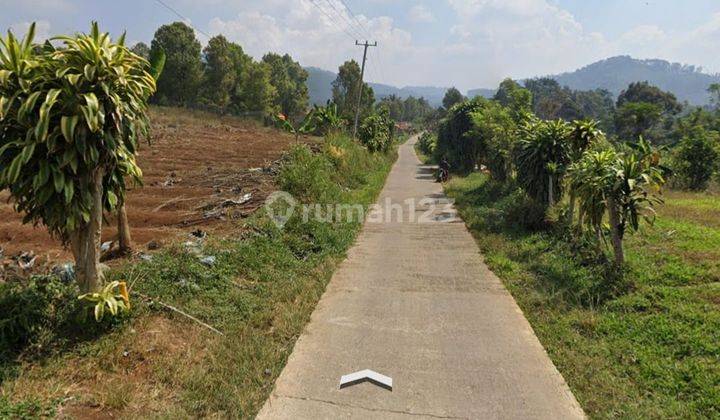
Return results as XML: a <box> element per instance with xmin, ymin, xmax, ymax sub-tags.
<box><xmin>0</xmin><ymin>20</ymin><xmax>402</xmax><ymax>418</ymax></box>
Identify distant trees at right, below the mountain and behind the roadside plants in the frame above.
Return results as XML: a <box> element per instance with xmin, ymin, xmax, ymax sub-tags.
<box><xmin>462</xmin><ymin>78</ymin><xmax>720</xmax><ymax>190</ymax></box>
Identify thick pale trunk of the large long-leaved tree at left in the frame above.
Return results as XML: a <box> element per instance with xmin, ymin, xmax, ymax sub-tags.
<box><xmin>70</xmin><ymin>168</ymin><xmax>104</xmax><ymax>293</ymax></box>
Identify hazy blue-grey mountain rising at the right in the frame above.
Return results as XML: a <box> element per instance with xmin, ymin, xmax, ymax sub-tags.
<box><xmin>468</xmin><ymin>55</ymin><xmax>720</xmax><ymax>105</ymax></box>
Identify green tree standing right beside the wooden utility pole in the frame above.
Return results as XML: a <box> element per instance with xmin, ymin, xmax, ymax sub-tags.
<box><xmin>332</xmin><ymin>60</ymin><xmax>375</xmax><ymax>121</ymax></box>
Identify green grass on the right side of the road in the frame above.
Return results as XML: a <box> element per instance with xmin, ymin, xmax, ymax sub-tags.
<box><xmin>447</xmin><ymin>174</ymin><xmax>720</xmax><ymax>418</ymax></box>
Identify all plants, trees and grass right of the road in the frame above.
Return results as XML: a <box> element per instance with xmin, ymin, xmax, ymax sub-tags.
<box><xmin>434</xmin><ymin>76</ymin><xmax>720</xmax><ymax>418</ymax></box>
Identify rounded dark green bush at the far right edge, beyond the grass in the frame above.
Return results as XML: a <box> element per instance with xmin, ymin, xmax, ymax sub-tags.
<box><xmin>674</xmin><ymin>132</ymin><xmax>718</xmax><ymax>191</ymax></box>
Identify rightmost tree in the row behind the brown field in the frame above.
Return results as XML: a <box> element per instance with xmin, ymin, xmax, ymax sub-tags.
<box><xmin>262</xmin><ymin>53</ymin><xmax>308</xmax><ymax>117</ymax></box>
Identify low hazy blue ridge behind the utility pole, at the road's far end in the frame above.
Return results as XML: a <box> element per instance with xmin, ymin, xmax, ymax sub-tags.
<box><xmin>305</xmin><ymin>67</ymin><xmax>448</xmax><ymax>107</ymax></box>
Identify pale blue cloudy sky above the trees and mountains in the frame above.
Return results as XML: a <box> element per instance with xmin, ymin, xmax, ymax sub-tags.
<box><xmin>0</xmin><ymin>0</ymin><xmax>720</xmax><ymax>90</ymax></box>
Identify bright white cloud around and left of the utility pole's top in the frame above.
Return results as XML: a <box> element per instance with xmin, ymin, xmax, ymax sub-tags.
<box><xmin>208</xmin><ymin>0</ymin><xmax>413</xmax><ymax>84</ymax></box>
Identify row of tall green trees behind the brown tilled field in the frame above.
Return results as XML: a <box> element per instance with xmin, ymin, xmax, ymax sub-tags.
<box><xmin>132</xmin><ymin>22</ymin><xmax>308</xmax><ymax>116</ymax></box>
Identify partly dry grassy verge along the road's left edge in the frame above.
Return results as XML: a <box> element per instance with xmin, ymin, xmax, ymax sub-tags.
<box><xmin>0</xmin><ymin>136</ymin><xmax>396</xmax><ymax>418</ymax></box>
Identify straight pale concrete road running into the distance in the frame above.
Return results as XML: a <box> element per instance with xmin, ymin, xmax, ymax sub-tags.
<box><xmin>258</xmin><ymin>139</ymin><xmax>584</xmax><ymax>419</ymax></box>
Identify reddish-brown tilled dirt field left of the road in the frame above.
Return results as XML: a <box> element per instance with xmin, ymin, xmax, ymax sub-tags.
<box><xmin>0</xmin><ymin>108</ymin><xmax>294</xmax><ymax>261</ymax></box>
